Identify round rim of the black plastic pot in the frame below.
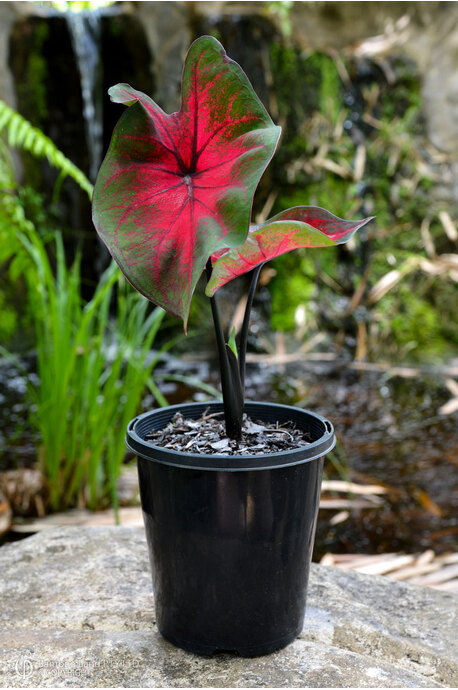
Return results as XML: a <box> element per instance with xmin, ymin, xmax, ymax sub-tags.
<box><xmin>126</xmin><ymin>401</ymin><xmax>336</xmax><ymax>472</ymax></box>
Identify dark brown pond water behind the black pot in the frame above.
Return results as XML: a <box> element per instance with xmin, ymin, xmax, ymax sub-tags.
<box><xmin>0</xmin><ymin>358</ymin><xmax>458</xmax><ymax>560</ymax></box>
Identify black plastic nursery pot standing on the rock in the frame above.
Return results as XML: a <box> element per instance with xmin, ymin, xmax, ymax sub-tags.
<box><xmin>126</xmin><ymin>403</ymin><xmax>335</xmax><ymax>656</ymax></box>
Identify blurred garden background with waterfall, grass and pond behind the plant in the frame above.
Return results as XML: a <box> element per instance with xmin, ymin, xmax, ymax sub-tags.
<box><xmin>0</xmin><ymin>1</ymin><xmax>458</xmax><ymax>589</ymax></box>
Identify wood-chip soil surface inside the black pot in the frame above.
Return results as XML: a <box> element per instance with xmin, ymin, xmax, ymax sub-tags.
<box><xmin>145</xmin><ymin>412</ymin><xmax>313</xmax><ymax>455</ymax></box>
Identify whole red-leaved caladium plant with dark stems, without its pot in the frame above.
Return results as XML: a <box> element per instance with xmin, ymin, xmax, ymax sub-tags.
<box><xmin>93</xmin><ymin>36</ymin><xmax>371</xmax><ymax>439</ymax></box>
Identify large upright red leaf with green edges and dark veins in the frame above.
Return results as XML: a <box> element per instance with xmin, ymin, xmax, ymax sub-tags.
<box><xmin>93</xmin><ymin>36</ymin><xmax>280</xmax><ymax>324</ymax></box>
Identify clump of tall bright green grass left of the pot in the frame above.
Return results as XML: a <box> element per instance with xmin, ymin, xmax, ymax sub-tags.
<box><xmin>20</xmin><ymin>227</ymin><xmax>168</xmax><ymax>510</ymax></box>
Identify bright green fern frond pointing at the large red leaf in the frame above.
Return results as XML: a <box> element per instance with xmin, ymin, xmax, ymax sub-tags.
<box><xmin>0</xmin><ymin>100</ymin><xmax>93</xmax><ymax>199</ymax></box>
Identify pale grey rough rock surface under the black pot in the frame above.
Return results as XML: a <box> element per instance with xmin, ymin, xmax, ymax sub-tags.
<box><xmin>0</xmin><ymin>527</ymin><xmax>458</xmax><ymax>688</ymax></box>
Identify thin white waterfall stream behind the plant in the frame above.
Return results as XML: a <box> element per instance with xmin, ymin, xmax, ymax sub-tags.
<box><xmin>65</xmin><ymin>11</ymin><xmax>103</xmax><ymax>182</ymax></box>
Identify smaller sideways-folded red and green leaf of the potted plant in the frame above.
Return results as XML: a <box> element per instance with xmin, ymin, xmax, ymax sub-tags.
<box><xmin>205</xmin><ymin>206</ymin><xmax>372</xmax><ymax>297</ymax></box>
